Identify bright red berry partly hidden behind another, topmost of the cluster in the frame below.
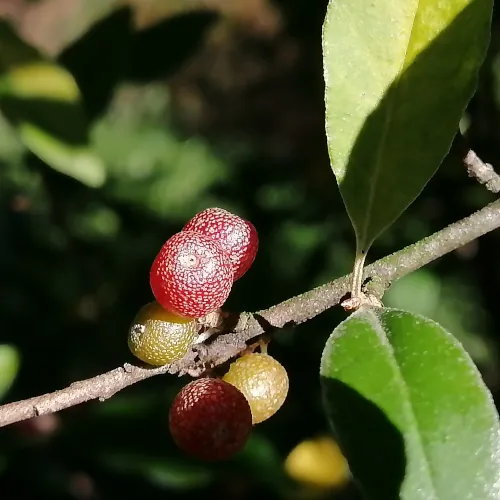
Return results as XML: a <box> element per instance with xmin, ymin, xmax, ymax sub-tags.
<box><xmin>183</xmin><ymin>208</ymin><xmax>259</xmax><ymax>281</ymax></box>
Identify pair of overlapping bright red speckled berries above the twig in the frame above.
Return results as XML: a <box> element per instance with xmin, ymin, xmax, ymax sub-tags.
<box><xmin>150</xmin><ymin>208</ymin><xmax>259</xmax><ymax>318</ymax></box>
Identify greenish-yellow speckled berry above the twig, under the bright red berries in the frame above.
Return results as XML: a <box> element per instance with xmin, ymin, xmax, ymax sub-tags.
<box><xmin>128</xmin><ymin>301</ymin><xmax>198</xmax><ymax>366</ymax></box>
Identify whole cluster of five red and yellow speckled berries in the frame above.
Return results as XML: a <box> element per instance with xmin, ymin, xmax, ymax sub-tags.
<box><xmin>128</xmin><ymin>208</ymin><xmax>288</xmax><ymax>460</ymax></box>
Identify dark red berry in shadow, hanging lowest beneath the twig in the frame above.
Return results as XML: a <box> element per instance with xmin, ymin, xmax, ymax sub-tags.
<box><xmin>169</xmin><ymin>378</ymin><xmax>252</xmax><ymax>460</ymax></box>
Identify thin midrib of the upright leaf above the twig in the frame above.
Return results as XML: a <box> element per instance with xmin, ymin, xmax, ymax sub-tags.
<box><xmin>357</xmin><ymin>0</ymin><xmax>420</xmax><ymax>251</ymax></box>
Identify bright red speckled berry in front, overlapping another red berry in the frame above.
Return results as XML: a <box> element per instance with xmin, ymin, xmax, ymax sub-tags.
<box><xmin>149</xmin><ymin>231</ymin><xmax>233</xmax><ymax>318</ymax></box>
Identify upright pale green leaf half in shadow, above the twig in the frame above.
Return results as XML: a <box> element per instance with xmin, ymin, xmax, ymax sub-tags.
<box><xmin>323</xmin><ymin>0</ymin><xmax>493</xmax><ymax>252</ymax></box>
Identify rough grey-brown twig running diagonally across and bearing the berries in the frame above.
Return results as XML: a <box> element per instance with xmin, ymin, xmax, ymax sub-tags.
<box><xmin>0</xmin><ymin>200</ymin><xmax>500</xmax><ymax>427</ymax></box>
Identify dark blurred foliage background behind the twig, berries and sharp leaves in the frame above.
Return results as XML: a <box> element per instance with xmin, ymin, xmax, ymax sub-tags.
<box><xmin>0</xmin><ymin>0</ymin><xmax>500</xmax><ymax>500</ymax></box>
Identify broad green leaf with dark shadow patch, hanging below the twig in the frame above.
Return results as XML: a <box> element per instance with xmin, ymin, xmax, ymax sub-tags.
<box><xmin>321</xmin><ymin>309</ymin><xmax>500</xmax><ymax>500</ymax></box>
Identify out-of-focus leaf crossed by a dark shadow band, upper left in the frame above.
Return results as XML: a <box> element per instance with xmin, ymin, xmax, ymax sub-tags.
<box><xmin>0</xmin><ymin>22</ymin><xmax>106</xmax><ymax>187</ymax></box>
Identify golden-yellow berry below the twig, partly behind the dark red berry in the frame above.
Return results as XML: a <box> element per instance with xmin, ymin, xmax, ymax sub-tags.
<box><xmin>222</xmin><ymin>353</ymin><xmax>288</xmax><ymax>424</ymax></box>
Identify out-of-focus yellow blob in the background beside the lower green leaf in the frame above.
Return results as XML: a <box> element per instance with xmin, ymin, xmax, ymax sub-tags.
<box><xmin>285</xmin><ymin>436</ymin><xmax>351</xmax><ymax>489</ymax></box>
